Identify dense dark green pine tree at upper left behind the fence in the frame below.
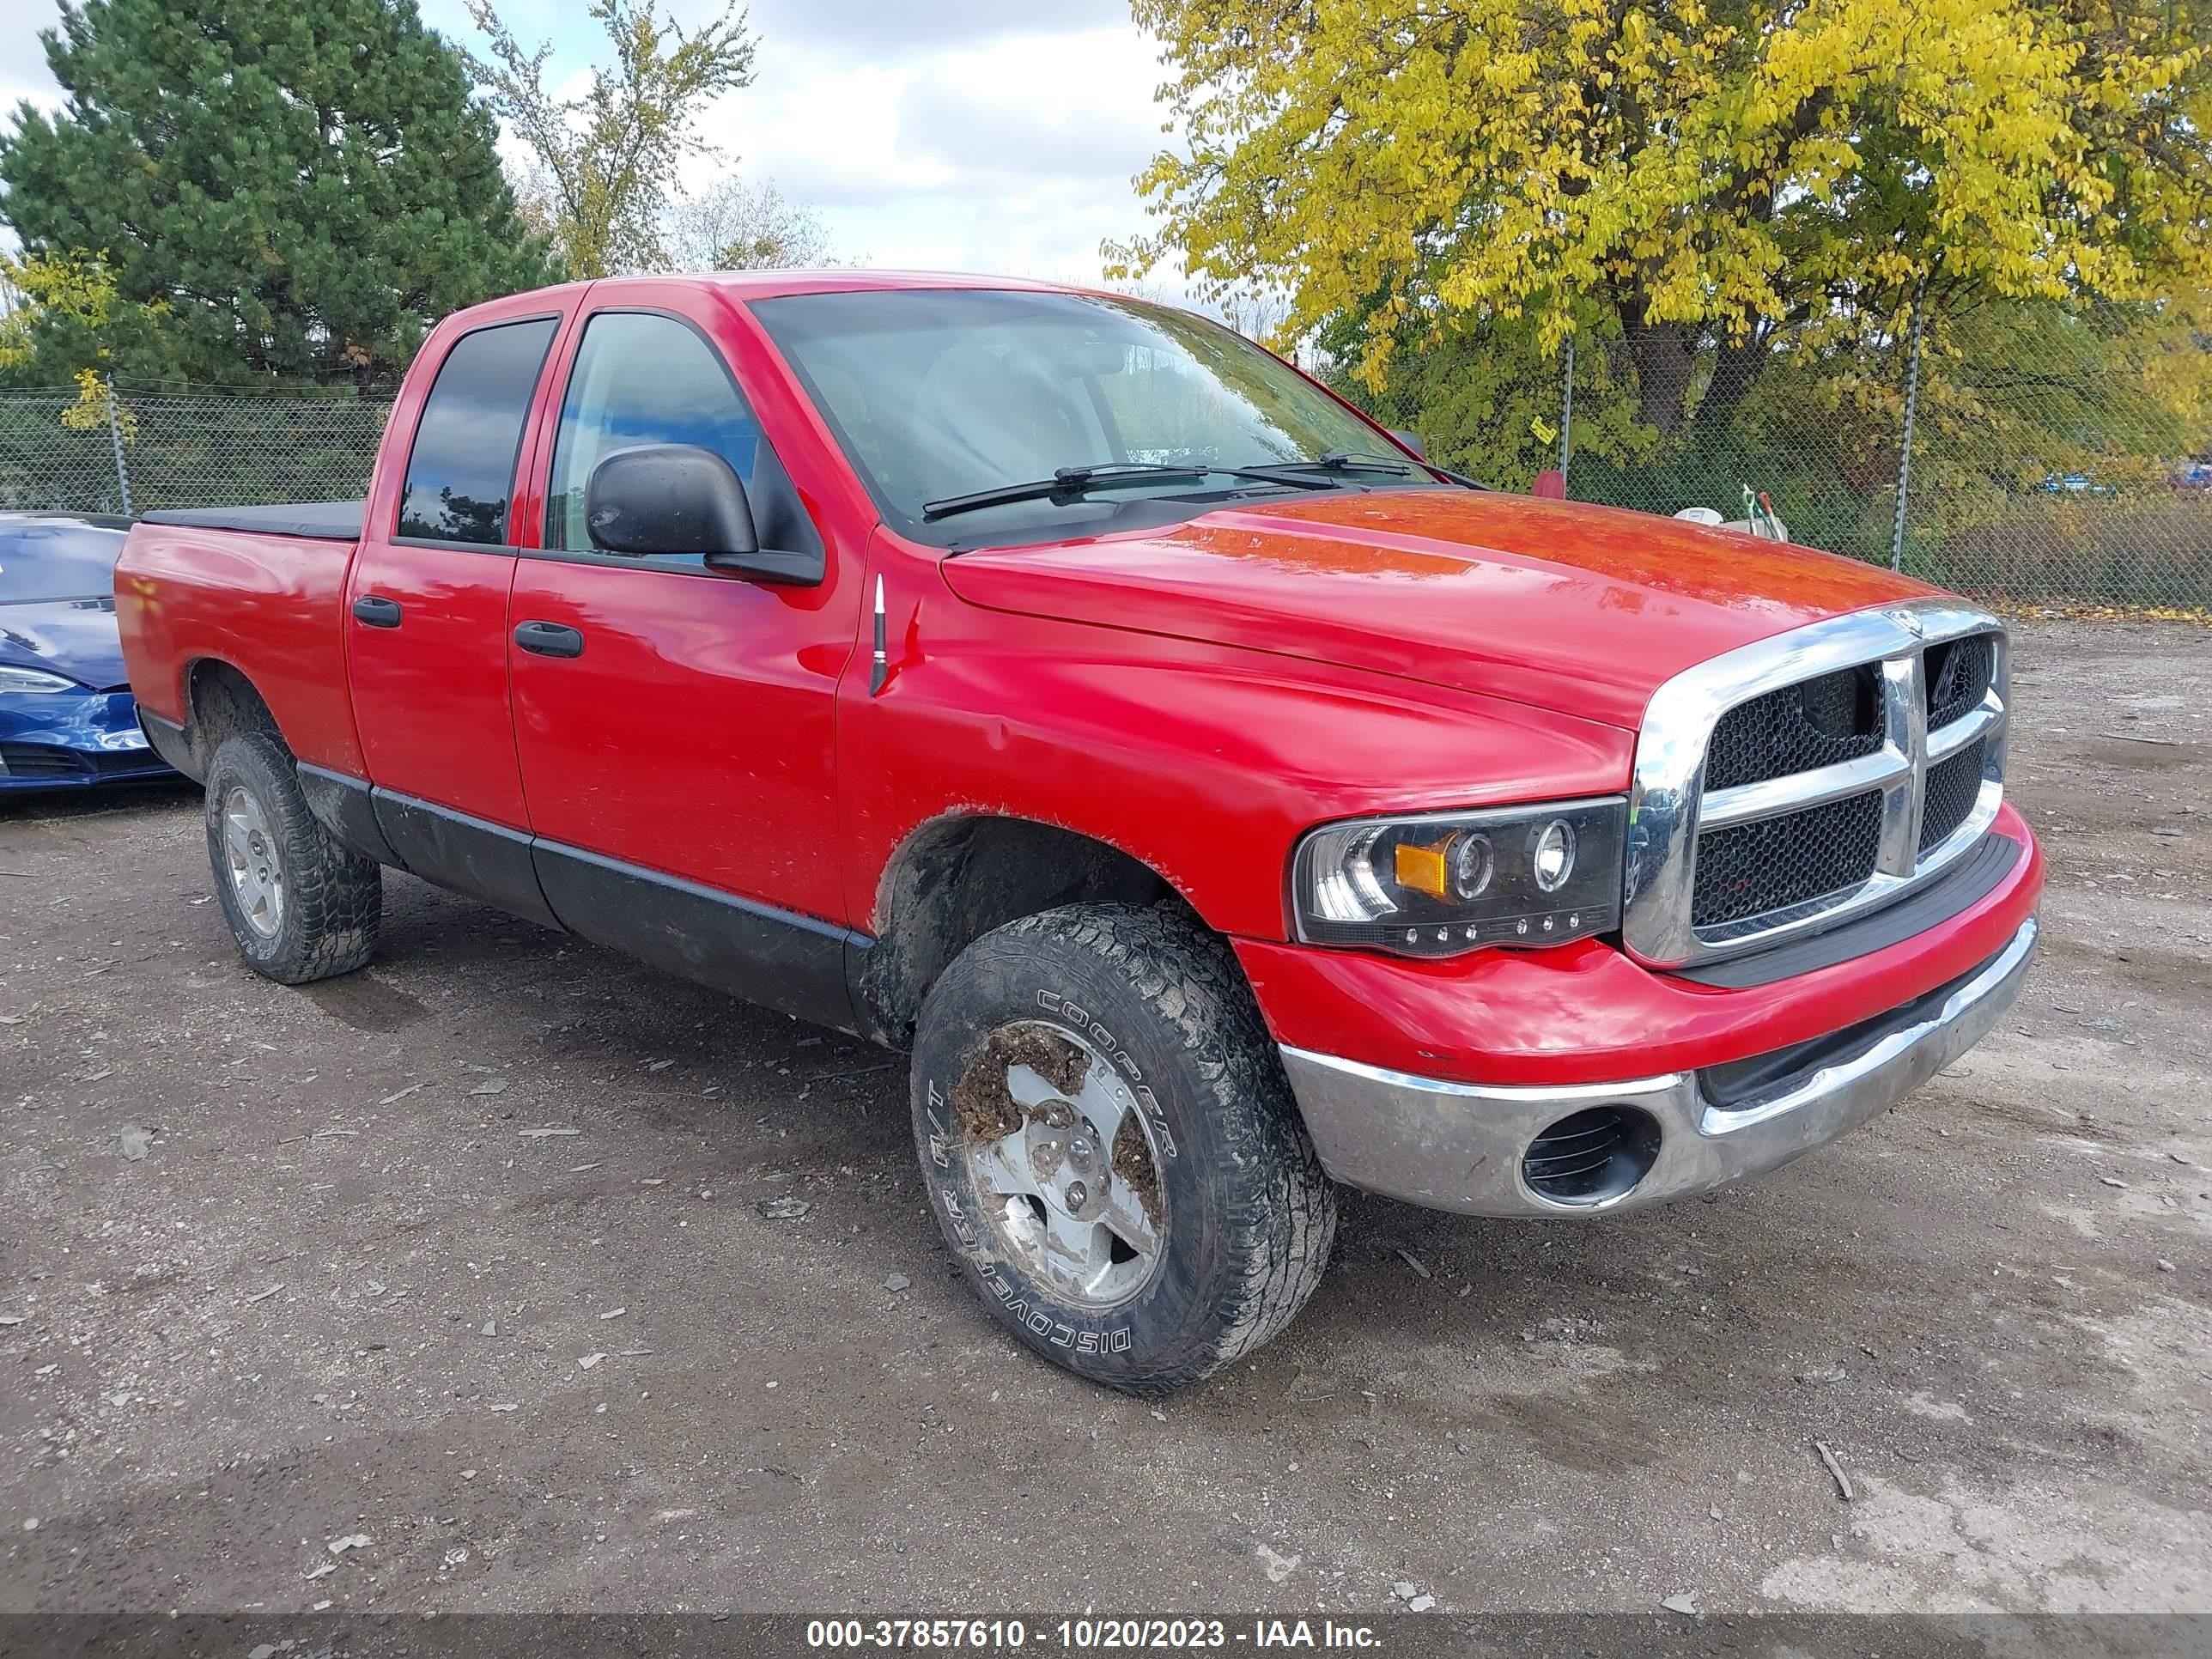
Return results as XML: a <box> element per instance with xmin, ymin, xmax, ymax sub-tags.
<box><xmin>0</xmin><ymin>0</ymin><xmax>556</xmax><ymax>385</ymax></box>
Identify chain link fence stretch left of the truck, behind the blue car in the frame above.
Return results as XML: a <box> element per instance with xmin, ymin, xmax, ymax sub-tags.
<box><xmin>0</xmin><ymin>383</ymin><xmax>392</xmax><ymax>514</ymax></box>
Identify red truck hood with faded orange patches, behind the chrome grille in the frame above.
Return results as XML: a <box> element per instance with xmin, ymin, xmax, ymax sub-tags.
<box><xmin>942</xmin><ymin>491</ymin><xmax>1933</xmax><ymax>730</ymax></box>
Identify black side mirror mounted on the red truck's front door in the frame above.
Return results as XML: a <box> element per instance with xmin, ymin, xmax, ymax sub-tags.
<box><xmin>584</xmin><ymin>445</ymin><xmax>821</xmax><ymax>584</ymax></box>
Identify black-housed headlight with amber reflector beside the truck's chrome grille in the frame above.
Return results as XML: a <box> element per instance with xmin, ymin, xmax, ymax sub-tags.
<box><xmin>1291</xmin><ymin>796</ymin><xmax>1628</xmax><ymax>956</ymax></box>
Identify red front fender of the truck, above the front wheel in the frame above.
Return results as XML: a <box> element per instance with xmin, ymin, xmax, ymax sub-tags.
<box><xmin>838</xmin><ymin>556</ymin><xmax>1635</xmax><ymax>940</ymax></box>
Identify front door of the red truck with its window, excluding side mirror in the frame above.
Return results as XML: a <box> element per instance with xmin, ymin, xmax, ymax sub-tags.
<box><xmin>508</xmin><ymin>285</ymin><xmax>858</xmax><ymax>1024</ymax></box>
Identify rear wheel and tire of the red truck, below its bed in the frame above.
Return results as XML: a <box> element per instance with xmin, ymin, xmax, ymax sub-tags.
<box><xmin>208</xmin><ymin>732</ymin><xmax>385</xmax><ymax>984</ymax></box>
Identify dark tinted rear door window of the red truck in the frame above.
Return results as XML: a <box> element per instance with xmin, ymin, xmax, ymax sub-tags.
<box><xmin>398</xmin><ymin>316</ymin><xmax>553</xmax><ymax>546</ymax></box>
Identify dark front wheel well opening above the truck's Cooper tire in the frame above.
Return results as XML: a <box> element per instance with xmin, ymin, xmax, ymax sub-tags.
<box><xmin>858</xmin><ymin>814</ymin><xmax>1194</xmax><ymax>1048</ymax></box>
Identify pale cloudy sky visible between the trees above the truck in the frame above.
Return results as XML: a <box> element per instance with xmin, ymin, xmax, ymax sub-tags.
<box><xmin>0</xmin><ymin>0</ymin><xmax>1176</xmax><ymax>289</ymax></box>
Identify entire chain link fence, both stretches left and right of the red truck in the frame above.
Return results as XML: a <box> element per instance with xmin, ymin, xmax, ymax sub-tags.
<box><xmin>0</xmin><ymin>330</ymin><xmax>2212</xmax><ymax>613</ymax></box>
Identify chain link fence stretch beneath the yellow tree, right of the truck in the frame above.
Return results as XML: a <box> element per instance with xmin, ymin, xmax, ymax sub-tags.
<box><xmin>1329</xmin><ymin>302</ymin><xmax>2212</xmax><ymax>615</ymax></box>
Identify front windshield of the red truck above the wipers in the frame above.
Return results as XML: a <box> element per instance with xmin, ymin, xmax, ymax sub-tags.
<box><xmin>752</xmin><ymin>288</ymin><xmax>1398</xmax><ymax>542</ymax></box>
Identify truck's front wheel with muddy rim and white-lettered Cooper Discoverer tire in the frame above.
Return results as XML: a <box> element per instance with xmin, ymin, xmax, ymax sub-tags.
<box><xmin>914</xmin><ymin>905</ymin><xmax>1336</xmax><ymax>1394</ymax></box>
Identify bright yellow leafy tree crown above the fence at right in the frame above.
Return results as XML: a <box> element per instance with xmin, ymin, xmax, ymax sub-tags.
<box><xmin>1110</xmin><ymin>0</ymin><xmax>2212</xmax><ymax>434</ymax></box>
